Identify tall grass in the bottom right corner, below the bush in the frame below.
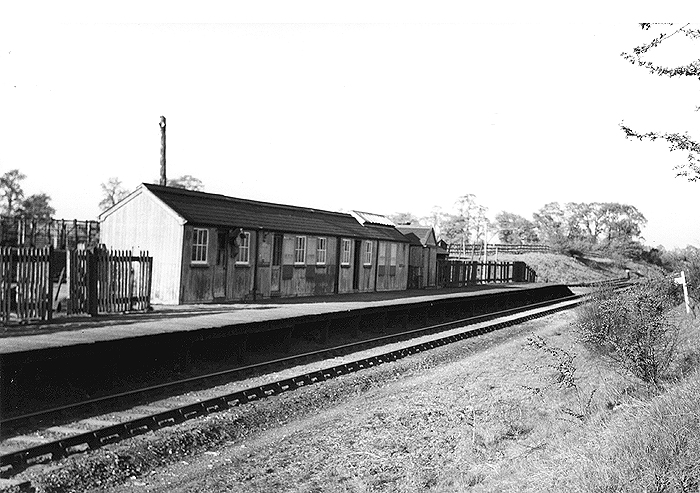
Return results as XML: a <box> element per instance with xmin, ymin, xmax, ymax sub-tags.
<box><xmin>554</xmin><ymin>373</ymin><xmax>700</xmax><ymax>492</ymax></box>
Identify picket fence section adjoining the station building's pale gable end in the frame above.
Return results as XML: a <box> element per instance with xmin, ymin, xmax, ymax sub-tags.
<box><xmin>68</xmin><ymin>249</ymin><xmax>153</xmax><ymax>315</ymax></box>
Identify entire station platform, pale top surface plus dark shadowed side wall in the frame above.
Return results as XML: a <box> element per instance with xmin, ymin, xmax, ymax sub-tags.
<box><xmin>0</xmin><ymin>284</ymin><xmax>572</xmax><ymax>416</ymax></box>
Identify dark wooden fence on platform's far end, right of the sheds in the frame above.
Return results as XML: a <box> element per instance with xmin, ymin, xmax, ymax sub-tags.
<box><xmin>437</xmin><ymin>260</ymin><xmax>537</xmax><ymax>287</ymax></box>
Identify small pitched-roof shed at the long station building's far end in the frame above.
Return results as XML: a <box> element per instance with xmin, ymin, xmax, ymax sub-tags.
<box><xmin>396</xmin><ymin>225</ymin><xmax>438</xmax><ymax>288</ymax></box>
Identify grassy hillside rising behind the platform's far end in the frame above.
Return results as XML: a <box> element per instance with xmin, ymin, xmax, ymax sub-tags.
<box><xmin>498</xmin><ymin>253</ymin><xmax>665</xmax><ymax>284</ymax></box>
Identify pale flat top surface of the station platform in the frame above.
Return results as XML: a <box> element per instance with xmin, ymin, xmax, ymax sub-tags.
<box><xmin>0</xmin><ymin>283</ymin><xmax>556</xmax><ymax>357</ymax></box>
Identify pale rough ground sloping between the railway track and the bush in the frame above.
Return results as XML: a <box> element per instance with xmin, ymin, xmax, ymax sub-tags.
<box><xmin>91</xmin><ymin>312</ymin><xmax>614</xmax><ymax>492</ymax></box>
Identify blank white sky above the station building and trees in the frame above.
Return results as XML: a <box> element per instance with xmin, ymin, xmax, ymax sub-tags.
<box><xmin>0</xmin><ymin>2</ymin><xmax>700</xmax><ymax>248</ymax></box>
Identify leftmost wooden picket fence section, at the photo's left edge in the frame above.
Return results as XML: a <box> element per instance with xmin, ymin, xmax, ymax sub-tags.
<box><xmin>0</xmin><ymin>247</ymin><xmax>53</xmax><ymax>325</ymax></box>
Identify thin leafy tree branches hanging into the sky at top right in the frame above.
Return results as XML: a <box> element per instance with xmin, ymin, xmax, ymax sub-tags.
<box><xmin>620</xmin><ymin>22</ymin><xmax>700</xmax><ymax>181</ymax></box>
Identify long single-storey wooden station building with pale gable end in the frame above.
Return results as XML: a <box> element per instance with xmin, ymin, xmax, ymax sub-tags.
<box><xmin>100</xmin><ymin>183</ymin><xmax>408</xmax><ymax>304</ymax></box>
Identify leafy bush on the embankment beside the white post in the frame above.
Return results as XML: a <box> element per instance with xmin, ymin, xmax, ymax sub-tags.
<box><xmin>576</xmin><ymin>279</ymin><xmax>682</xmax><ymax>385</ymax></box>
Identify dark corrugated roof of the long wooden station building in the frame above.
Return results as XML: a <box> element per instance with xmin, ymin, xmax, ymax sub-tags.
<box><xmin>143</xmin><ymin>183</ymin><xmax>407</xmax><ymax>242</ymax></box>
